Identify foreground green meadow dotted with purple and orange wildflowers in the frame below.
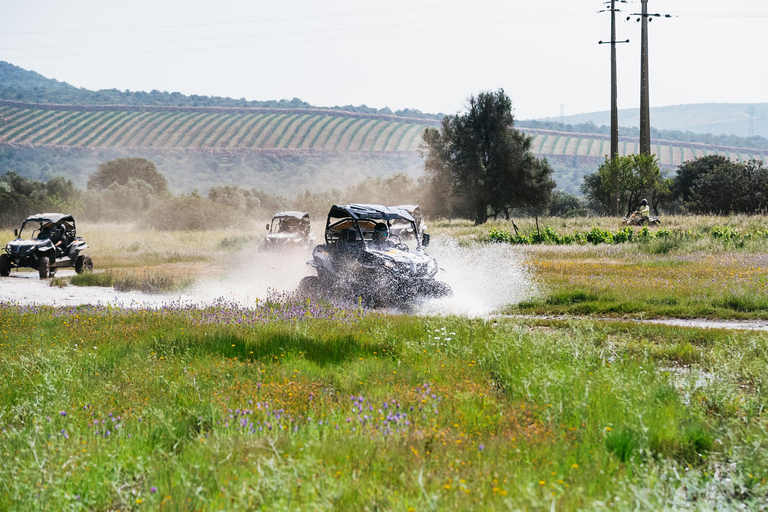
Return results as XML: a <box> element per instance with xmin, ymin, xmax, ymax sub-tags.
<box><xmin>0</xmin><ymin>297</ymin><xmax>768</xmax><ymax>510</ymax></box>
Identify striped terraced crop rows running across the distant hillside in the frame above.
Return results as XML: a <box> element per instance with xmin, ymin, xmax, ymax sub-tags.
<box><xmin>0</xmin><ymin>101</ymin><xmax>768</xmax><ymax>167</ymax></box>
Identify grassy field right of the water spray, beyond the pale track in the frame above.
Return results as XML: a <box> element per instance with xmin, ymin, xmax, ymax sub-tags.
<box><xmin>435</xmin><ymin>216</ymin><xmax>768</xmax><ymax>319</ymax></box>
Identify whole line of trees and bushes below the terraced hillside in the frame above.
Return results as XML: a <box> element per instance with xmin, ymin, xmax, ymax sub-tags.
<box><xmin>0</xmin><ymin>89</ymin><xmax>768</xmax><ymax>229</ymax></box>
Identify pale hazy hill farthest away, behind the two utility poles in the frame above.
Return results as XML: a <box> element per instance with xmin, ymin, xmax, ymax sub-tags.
<box><xmin>545</xmin><ymin>103</ymin><xmax>768</xmax><ymax>137</ymax></box>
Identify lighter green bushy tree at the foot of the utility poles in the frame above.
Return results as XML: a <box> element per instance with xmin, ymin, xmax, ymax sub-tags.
<box><xmin>581</xmin><ymin>155</ymin><xmax>672</xmax><ymax>214</ymax></box>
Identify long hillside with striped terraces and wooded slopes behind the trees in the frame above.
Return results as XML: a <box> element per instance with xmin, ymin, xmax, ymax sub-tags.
<box><xmin>0</xmin><ymin>62</ymin><xmax>768</xmax><ymax>194</ymax></box>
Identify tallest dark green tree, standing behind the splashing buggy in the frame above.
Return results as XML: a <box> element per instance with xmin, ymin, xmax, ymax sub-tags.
<box><xmin>420</xmin><ymin>89</ymin><xmax>555</xmax><ymax>224</ymax></box>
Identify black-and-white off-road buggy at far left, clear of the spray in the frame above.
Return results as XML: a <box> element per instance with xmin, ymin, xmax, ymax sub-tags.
<box><xmin>0</xmin><ymin>213</ymin><xmax>93</xmax><ymax>278</ymax></box>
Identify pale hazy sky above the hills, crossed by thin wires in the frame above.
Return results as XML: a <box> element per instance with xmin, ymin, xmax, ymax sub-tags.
<box><xmin>0</xmin><ymin>0</ymin><xmax>768</xmax><ymax>119</ymax></box>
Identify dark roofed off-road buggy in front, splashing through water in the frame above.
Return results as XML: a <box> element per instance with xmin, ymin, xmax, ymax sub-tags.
<box><xmin>299</xmin><ymin>204</ymin><xmax>453</xmax><ymax>307</ymax></box>
